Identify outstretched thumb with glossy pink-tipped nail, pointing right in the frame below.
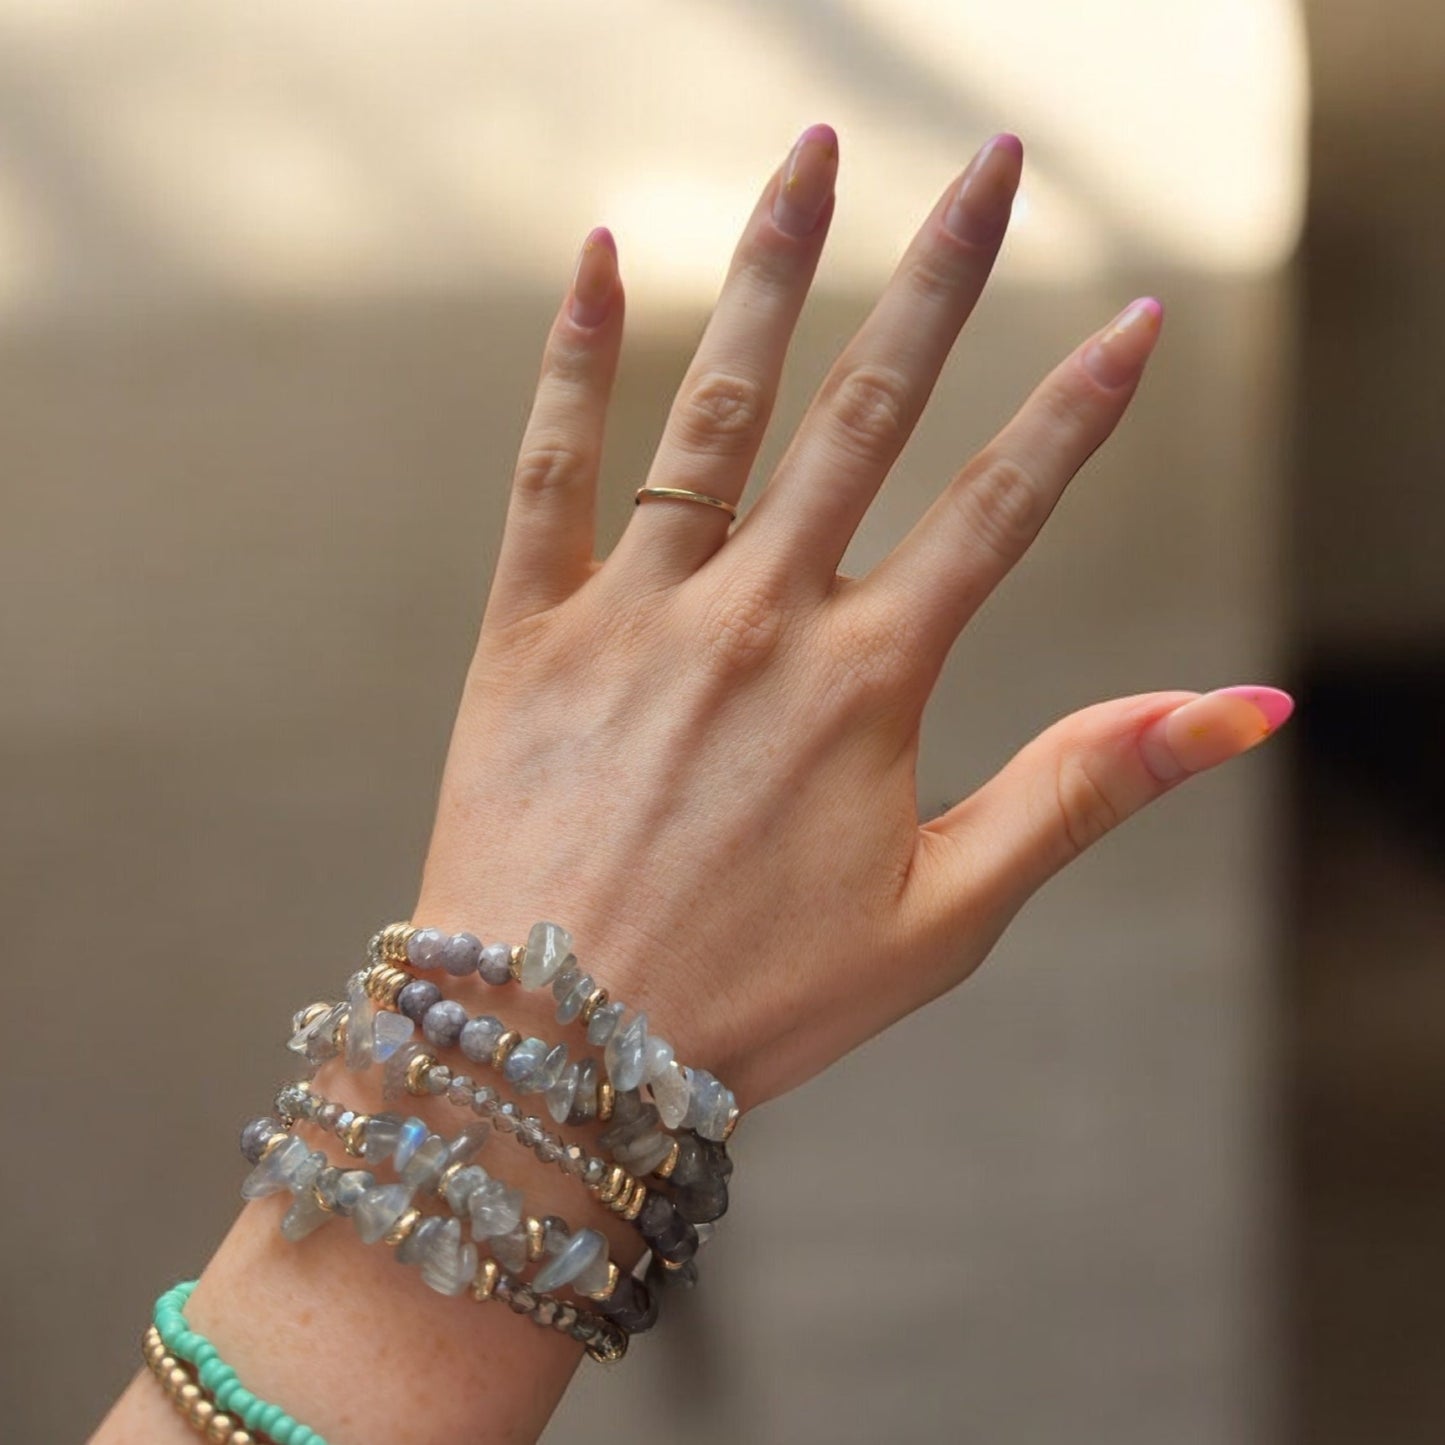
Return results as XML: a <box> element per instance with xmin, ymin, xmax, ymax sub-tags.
<box><xmin>925</xmin><ymin>685</ymin><xmax>1295</xmax><ymax>906</ymax></box>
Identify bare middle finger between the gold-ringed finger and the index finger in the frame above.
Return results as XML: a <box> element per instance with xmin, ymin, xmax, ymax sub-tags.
<box><xmin>738</xmin><ymin>133</ymin><xmax>1023</xmax><ymax>587</ymax></box>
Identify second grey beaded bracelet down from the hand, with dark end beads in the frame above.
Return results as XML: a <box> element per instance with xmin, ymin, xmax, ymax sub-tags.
<box><xmin>363</xmin><ymin>953</ymin><xmax>733</xmax><ymax>1224</ymax></box>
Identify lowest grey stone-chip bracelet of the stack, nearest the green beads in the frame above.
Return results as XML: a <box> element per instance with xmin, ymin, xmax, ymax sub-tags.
<box><xmin>241</xmin><ymin>1084</ymin><xmax>638</xmax><ymax>1361</ymax></box>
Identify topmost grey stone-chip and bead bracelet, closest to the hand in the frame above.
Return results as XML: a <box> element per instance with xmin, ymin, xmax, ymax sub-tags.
<box><xmin>370</xmin><ymin>922</ymin><xmax>738</xmax><ymax>1143</ymax></box>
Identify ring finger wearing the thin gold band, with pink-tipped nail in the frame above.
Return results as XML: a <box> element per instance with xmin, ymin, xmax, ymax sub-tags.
<box><xmin>613</xmin><ymin>126</ymin><xmax>838</xmax><ymax>581</ymax></box>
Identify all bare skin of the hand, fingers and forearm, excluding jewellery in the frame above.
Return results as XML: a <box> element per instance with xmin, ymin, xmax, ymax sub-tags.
<box><xmin>92</xmin><ymin>127</ymin><xmax>1287</xmax><ymax>1445</ymax></box>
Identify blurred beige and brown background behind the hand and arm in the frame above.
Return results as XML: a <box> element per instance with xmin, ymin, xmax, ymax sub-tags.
<box><xmin>0</xmin><ymin>0</ymin><xmax>1445</xmax><ymax>1445</ymax></box>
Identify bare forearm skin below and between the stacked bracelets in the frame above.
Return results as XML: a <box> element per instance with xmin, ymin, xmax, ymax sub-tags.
<box><xmin>94</xmin><ymin>987</ymin><xmax>643</xmax><ymax>1445</ymax></box>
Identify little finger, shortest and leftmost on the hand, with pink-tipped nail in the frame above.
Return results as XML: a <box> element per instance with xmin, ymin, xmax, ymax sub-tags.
<box><xmin>487</xmin><ymin>225</ymin><xmax>624</xmax><ymax>621</ymax></box>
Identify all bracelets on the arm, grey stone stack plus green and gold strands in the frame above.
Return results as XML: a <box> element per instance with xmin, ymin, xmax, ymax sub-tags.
<box><xmin>143</xmin><ymin>922</ymin><xmax>738</xmax><ymax>1445</ymax></box>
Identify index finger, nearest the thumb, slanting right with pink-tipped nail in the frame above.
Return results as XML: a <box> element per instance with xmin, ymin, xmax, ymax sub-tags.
<box><xmin>850</xmin><ymin>298</ymin><xmax>1163</xmax><ymax>683</ymax></box>
